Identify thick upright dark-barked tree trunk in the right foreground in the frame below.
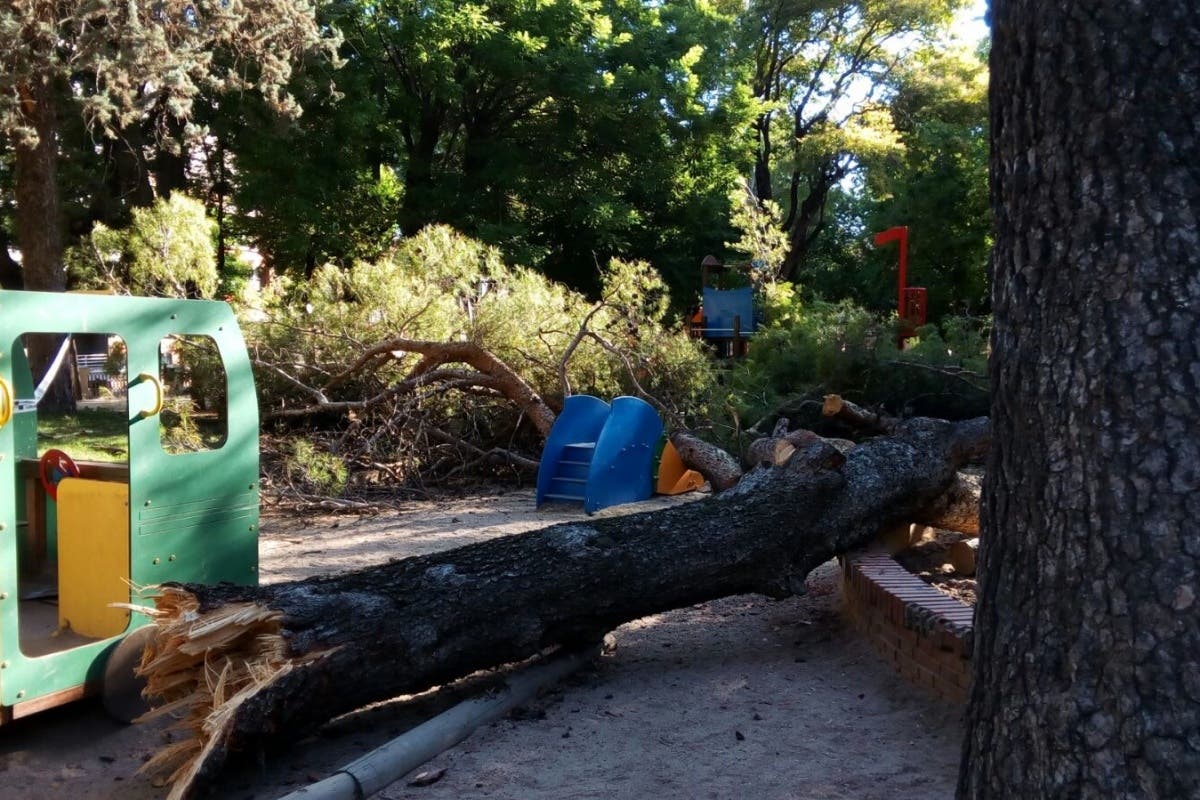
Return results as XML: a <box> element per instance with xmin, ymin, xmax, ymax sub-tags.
<box><xmin>959</xmin><ymin>0</ymin><xmax>1200</xmax><ymax>800</ymax></box>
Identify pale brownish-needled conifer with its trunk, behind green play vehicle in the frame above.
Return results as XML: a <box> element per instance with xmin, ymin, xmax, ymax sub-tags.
<box><xmin>0</xmin><ymin>0</ymin><xmax>334</xmax><ymax>290</ymax></box>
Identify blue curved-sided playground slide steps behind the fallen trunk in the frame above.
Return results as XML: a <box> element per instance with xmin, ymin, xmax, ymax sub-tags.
<box><xmin>538</xmin><ymin>395</ymin><xmax>662</xmax><ymax>513</ymax></box>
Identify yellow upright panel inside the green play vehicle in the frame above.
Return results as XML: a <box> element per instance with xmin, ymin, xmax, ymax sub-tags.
<box><xmin>58</xmin><ymin>477</ymin><xmax>130</xmax><ymax>638</ymax></box>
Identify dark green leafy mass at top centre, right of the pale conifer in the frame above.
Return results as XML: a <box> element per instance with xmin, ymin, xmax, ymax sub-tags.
<box><xmin>229</xmin><ymin>0</ymin><xmax>751</xmax><ymax>291</ymax></box>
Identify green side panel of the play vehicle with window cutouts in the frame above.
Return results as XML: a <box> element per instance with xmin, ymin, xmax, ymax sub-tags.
<box><xmin>0</xmin><ymin>291</ymin><xmax>258</xmax><ymax>705</ymax></box>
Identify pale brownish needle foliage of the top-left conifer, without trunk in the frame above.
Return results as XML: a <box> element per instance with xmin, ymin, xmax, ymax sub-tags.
<box><xmin>0</xmin><ymin>0</ymin><xmax>336</xmax><ymax>142</ymax></box>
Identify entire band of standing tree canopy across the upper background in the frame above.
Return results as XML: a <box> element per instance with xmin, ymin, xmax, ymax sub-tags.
<box><xmin>0</xmin><ymin>0</ymin><xmax>986</xmax><ymax>313</ymax></box>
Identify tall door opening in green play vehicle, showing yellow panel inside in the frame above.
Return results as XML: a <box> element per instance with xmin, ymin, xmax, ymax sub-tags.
<box><xmin>12</xmin><ymin>332</ymin><xmax>130</xmax><ymax>656</ymax></box>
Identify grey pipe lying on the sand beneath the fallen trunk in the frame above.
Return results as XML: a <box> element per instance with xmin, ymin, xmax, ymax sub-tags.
<box><xmin>280</xmin><ymin>646</ymin><xmax>600</xmax><ymax>800</ymax></box>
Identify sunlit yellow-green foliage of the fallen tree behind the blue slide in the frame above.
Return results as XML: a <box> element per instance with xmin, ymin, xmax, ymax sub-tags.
<box><xmin>245</xmin><ymin>225</ymin><xmax>712</xmax><ymax>468</ymax></box>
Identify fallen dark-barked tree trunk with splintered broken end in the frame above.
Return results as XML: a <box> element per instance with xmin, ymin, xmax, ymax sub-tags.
<box><xmin>142</xmin><ymin>420</ymin><xmax>988</xmax><ymax>800</ymax></box>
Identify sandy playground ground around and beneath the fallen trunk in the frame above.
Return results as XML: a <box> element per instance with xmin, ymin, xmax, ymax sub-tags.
<box><xmin>0</xmin><ymin>491</ymin><xmax>961</xmax><ymax>800</ymax></box>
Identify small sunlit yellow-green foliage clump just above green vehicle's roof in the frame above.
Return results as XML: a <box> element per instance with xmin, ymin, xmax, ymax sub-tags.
<box><xmin>66</xmin><ymin>193</ymin><xmax>217</xmax><ymax>297</ymax></box>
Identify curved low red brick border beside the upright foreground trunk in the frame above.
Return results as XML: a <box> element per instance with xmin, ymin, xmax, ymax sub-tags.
<box><xmin>838</xmin><ymin>553</ymin><xmax>974</xmax><ymax>704</ymax></box>
